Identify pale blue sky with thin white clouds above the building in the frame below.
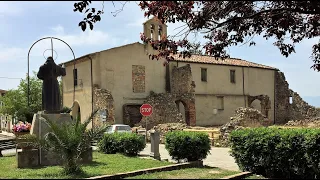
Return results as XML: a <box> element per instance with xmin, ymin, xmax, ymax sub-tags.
<box><xmin>0</xmin><ymin>1</ymin><xmax>320</xmax><ymax>107</ymax></box>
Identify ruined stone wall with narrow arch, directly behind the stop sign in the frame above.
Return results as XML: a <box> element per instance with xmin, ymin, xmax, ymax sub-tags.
<box><xmin>136</xmin><ymin>64</ymin><xmax>196</xmax><ymax>129</ymax></box>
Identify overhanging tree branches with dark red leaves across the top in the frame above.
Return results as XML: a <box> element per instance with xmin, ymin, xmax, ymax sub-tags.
<box><xmin>74</xmin><ymin>1</ymin><xmax>320</xmax><ymax>71</ymax></box>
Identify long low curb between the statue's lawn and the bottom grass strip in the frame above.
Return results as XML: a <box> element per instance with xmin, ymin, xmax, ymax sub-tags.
<box><xmin>86</xmin><ymin>161</ymin><xmax>203</xmax><ymax>179</ymax></box>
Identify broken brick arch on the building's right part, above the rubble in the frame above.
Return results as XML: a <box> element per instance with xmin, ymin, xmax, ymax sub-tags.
<box><xmin>248</xmin><ymin>95</ymin><xmax>271</xmax><ymax>117</ymax></box>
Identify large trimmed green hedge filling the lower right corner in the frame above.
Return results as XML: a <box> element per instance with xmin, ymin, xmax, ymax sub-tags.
<box><xmin>230</xmin><ymin>127</ymin><xmax>320</xmax><ymax>179</ymax></box>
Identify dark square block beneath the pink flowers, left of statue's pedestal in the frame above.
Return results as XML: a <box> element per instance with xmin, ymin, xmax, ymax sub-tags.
<box><xmin>16</xmin><ymin>149</ymin><xmax>39</xmax><ymax>168</ymax></box>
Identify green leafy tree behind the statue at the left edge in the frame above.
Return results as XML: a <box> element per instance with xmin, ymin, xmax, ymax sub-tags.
<box><xmin>0</xmin><ymin>72</ymin><xmax>42</xmax><ymax>122</ymax></box>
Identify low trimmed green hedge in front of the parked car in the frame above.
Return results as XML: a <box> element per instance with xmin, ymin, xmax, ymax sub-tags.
<box><xmin>98</xmin><ymin>133</ymin><xmax>146</xmax><ymax>156</ymax></box>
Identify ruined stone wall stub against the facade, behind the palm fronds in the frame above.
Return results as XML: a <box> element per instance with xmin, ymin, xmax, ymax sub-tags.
<box><xmin>93</xmin><ymin>85</ymin><xmax>115</xmax><ymax>126</ymax></box>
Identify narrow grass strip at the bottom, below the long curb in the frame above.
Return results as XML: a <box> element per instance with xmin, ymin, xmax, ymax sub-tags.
<box><xmin>126</xmin><ymin>166</ymin><xmax>239</xmax><ymax>179</ymax></box>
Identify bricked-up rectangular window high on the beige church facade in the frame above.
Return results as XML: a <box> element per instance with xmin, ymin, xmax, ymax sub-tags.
<box><xmin>132</xmin><ymin>65</ymin><xmax>146</xmax><ymax>93</ymax></box>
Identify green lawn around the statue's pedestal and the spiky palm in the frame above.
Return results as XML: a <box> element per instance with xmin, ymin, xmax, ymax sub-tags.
<box><xmin>0</xmin><ymin>152</ymin><xmax>172</xmax><ymax>179</ymax></box>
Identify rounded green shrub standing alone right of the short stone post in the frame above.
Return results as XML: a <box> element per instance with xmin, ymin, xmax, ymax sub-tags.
<box><xmin>165</xmin><ymin>131</ymin><xmax>211</xmax><ymax>161</ymax></box>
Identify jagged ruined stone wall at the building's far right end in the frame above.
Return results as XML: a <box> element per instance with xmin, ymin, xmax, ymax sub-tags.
<box><xmin>275</xmin><ymin>71</ymin><xmax>320</xmax><ymax>124</ymax></box>
